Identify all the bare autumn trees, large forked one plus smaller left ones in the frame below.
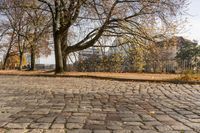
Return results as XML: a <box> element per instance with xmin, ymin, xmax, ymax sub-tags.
<box><xmin>0</xmin><ymin>0</ymin><xmax>187</xmax><ymax>73</ymax></box>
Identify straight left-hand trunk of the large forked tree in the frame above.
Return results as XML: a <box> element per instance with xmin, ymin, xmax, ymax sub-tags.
<box><xmin>54</xmin><ymin>33</ymin><xmax>64</xmax><ymax>73</ymax></box>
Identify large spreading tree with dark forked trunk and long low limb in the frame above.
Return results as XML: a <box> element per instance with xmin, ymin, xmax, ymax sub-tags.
<box><xmin>38</xmin><ymin>0</ymin><xmax>186</xmax><ymax>73</ymax></box>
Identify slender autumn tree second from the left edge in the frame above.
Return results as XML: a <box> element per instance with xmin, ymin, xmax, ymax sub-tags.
<box><xmin>1</xmin><ymin>0</ymin><xmax>30</xmax><ymax>70</ymax></box>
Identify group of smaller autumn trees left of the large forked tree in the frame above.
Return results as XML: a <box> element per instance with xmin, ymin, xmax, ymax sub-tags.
<box><xmin>0</xmin><ymin>0</ymin><xmax>51</xmax><ymax>70</ymax></box>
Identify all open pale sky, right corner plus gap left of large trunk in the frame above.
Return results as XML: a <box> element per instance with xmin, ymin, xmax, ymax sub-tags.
<box><xmin>39</xmin><ymin>0</ymin><xmax>200</xmax><ymax>64</ymax></box>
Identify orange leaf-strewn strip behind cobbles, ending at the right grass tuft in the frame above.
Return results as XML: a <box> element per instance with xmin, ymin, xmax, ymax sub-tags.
<box><xmin>0</xmin><ymin>70</ymin><xmax>181</xmax><ymax>81</ymax></box>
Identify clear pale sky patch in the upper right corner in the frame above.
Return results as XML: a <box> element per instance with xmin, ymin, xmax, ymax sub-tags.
<box><xmin>179</xmin><ymin>0</ymin><xmax>200</xmax><ymax>43</ymax></box>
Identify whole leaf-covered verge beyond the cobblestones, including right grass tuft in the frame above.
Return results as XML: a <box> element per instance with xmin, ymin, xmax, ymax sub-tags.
<box><xmin>0</xmin><ymin>70</ymin><xmax>200</xmax><ymax>83</ymax></box>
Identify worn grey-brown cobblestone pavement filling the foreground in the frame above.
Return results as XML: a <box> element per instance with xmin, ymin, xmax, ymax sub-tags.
<box><xmin>0</xmin><ymin>76</ymin><xmax>200</xmax><ymax>133</ymax></box>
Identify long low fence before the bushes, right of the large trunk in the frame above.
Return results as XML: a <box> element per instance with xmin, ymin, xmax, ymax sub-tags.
<box><xmin>69</xmin><ymin>58</ymin><xmax>200</xmax><ymax>73</ymax></box>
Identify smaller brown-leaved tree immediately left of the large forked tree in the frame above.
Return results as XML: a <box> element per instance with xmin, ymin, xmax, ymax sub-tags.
<box><xmin>25</xmin><ymin>2</ymin><xmax>51</xmax><ymax>70</ymax></box>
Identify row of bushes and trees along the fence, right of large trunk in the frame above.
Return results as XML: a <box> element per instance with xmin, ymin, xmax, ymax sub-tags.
<box><xmin>74</xmin><ymin>37</ymin><xmax>200</xmax><ymax>73</ymax></box>
